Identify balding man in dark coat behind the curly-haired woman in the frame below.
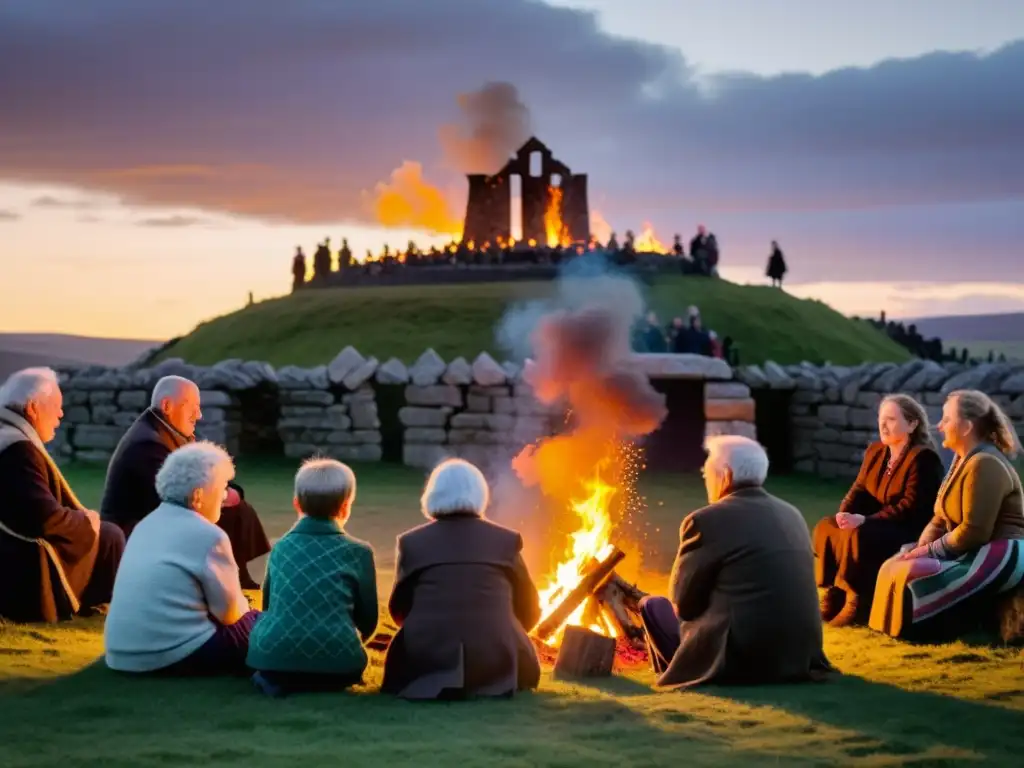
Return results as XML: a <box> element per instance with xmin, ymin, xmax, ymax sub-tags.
<box><xmin>99</xmin><ymin>376</ymin><xmax>270</xmax><ymax>589</ymax></box>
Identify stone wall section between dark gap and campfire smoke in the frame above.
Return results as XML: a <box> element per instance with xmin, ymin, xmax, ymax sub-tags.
<box><xmin>398</xmin><ymin>349</ymin><xmax>553</xmax><ymax>468</ymax></box>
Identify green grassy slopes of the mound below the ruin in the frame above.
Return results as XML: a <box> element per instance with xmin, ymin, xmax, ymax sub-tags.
<box><xmin>155</xmin><ymin>276</ymin><xmax>909</xmax><ymax>366</ymax></box>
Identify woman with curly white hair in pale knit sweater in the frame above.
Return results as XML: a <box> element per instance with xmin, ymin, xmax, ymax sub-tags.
<box><xmin>103</xmin><ymin>442</ymin><xmax>259</xmax><ymax>675</ymax></box>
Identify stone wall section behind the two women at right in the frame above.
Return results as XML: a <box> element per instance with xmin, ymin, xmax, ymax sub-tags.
<box><xmin>739</xmin><ymin>359</ymin><xmax>1024</xmax><ymax>478</ymax></box>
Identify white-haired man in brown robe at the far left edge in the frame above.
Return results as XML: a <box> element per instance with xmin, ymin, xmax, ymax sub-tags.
<box><xmin>0</xmin><ymin>368</ymin><xmax>125</xmax><ymax>622</ymax></box>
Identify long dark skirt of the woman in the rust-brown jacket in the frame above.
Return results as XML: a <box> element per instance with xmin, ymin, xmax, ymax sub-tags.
<box><xmin>812</xmin><ymin>516</ymin><xmax>921</xmax><ymax>599</ymax></box>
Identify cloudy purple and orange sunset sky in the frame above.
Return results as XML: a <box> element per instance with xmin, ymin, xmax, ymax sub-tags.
<box><xmin>0</xmin><ymin>0</ymin><xmax>1024</xmax><ymax>339</ymax></box>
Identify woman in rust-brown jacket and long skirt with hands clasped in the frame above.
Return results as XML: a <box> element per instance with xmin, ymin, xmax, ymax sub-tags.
<box><xmin>812</xmin><ymin>394</ymin><xmax>943</xmax><ymax>627</ymax></box>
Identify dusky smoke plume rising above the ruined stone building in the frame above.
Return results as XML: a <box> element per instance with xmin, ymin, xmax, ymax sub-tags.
<box><xmin>440</xmin><ymin>82</ymin><xmax>531</xmax><ymax>173</ymax></box>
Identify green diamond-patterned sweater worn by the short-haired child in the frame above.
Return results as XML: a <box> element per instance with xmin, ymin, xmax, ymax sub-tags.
<box><xmin>247</xmin><ymin>517</ymin><xmax>378</xmax><ymax>676</ymax></box>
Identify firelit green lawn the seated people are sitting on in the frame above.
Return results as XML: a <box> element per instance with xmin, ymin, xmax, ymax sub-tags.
<box><xmin>0</xmin><ymin>462</ymin><xmax>1024</xmax><ymax>768</ymax></box>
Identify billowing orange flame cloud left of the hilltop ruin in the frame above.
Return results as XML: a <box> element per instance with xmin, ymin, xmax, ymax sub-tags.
<box><xmin>374</xmin><ymin>160</ymin><xmax>462</xmax><ymax>241</ymax></box>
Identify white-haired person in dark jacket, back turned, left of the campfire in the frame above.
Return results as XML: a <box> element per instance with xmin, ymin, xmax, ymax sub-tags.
<box><xmin>382</xmin><ymin>459</ymin><xmax>541</xmax><ymax>699</ymax></box>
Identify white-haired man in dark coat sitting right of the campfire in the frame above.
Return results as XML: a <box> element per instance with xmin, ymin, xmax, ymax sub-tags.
<box><xmin>640</xmin><ymin>435</ymin><xmax>830</xmax><ymax>687</ymax></box>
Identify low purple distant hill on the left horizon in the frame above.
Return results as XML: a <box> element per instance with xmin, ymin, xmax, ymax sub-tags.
<box><xmin>0</xmin><ymin>333</ymin><xmax>161</xmax><ymax>381</ymax></box>
